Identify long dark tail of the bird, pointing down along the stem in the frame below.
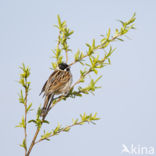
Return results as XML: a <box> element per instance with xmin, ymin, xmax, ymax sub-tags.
<box><xmin>41</xmin><ymin>94</ymin><xmax>54</xmax><ymax>117</ymax></box>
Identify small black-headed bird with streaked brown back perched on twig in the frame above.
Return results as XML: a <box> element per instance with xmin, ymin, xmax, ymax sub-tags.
<box><xmin>40</xmin><ymin>63</ymin><xmax>72</xmax><ymax>117</ymax></box>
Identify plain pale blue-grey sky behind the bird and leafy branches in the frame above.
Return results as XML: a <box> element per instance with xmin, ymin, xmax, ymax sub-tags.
<box><xmin>0</xmin><ymin>0</ymin><xmax>156</xmax><ymax>156</ymax></box>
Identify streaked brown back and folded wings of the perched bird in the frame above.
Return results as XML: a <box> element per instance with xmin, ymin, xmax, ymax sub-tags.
<box><xmin>45</xmin><ymin>70</ymin><xmax>71</xmax><ymax>95</ymax></box>
